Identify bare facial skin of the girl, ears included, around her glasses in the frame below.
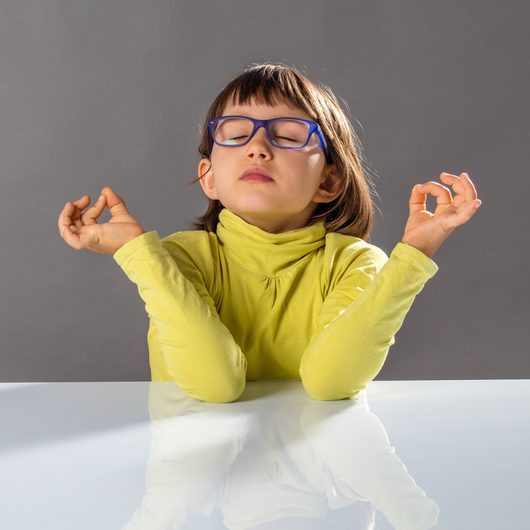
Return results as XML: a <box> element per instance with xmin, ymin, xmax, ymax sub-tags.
<box><xmin>198</xmin><ymin>97</ymin><xmax>342</xmax><ymax>233</ymax></box>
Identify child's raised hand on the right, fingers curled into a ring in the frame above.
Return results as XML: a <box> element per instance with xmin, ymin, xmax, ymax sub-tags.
<box><xmin>402</xmin><ymin>173</ymin><xmax>482</xmax><ymax>258</ymax></box>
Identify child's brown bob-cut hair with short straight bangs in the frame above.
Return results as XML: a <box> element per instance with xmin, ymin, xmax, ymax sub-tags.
<box><xmin>190</xmin><ymin>63</ymin><xmax>375</xmax><ymax>239</ymax></box>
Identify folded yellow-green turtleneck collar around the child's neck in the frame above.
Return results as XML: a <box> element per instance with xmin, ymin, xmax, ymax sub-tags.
<box><xmin>216</xmin><ymin>208</ymin><xmax>326</xmax><ymax>276</ymax></box>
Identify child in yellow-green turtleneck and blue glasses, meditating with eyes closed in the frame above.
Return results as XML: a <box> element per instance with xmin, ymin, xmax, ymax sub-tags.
<box><xmin>58</xmin><ymin>63</ymin><xmax>481</xmax><ymax>402</ymax></box>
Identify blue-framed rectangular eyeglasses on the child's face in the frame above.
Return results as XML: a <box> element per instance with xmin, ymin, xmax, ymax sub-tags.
<box><xmin>208</xmin><ymin>116</ymin><xmax>331</xmax><ymax>162</ymax></box>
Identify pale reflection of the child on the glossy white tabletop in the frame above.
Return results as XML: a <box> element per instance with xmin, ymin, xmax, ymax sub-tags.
<box><xmin>123</xmin><ymin>383</ymin><xmax>442</xmax><ymax>530</ymax></box>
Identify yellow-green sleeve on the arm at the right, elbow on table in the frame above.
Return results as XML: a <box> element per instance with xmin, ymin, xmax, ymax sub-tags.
<box><xmin>300</xmin><ymin>242</ymin><xmax>438</xmax><ymax>400</ymax></box>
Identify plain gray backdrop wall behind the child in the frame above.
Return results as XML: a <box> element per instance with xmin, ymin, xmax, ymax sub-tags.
<box><xmin>0</xmin><ymin>0</ymin><xmax>530</xmax><ymax>381</ymax></box>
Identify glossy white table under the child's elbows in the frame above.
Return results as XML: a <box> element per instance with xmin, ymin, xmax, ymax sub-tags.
<box><xmin>0</xmin><ymin>380</ymin><xmax>530</xmax><ymax>530</ymax></box>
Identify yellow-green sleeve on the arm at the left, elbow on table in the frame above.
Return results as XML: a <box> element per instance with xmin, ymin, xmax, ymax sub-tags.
<box><xmin>113</xmin><ymin>231</ymin><xmax>247</xmax><ymax>402</ymax></box>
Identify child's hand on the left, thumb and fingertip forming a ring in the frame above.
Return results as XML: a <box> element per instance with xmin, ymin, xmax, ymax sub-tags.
<box><xmin>57</xmin><ymin>186</ymin><xmax>145</xmax><ymax>254</ymax></box>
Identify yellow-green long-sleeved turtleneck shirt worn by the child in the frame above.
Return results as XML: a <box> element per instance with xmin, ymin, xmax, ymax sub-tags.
<box><xmin>113</xmin><ymin>208</ymin><xmax>438</xmax><ymax>402</ymax></box>
